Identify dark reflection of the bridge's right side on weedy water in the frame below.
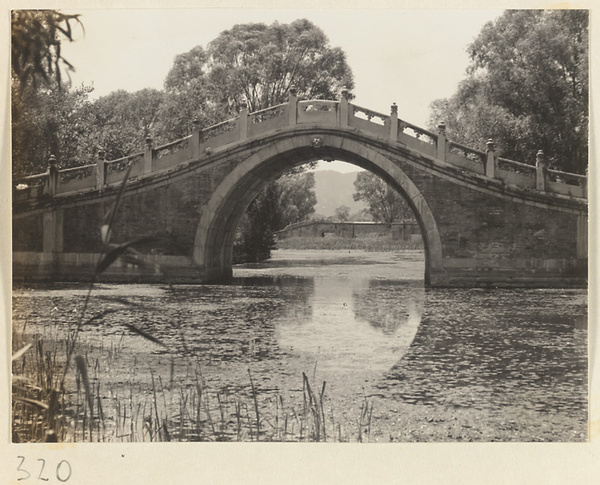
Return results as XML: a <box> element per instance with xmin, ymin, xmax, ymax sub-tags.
<box><xmin>378</xmin><ymin>289</ymin><xmax>587</xmax><ymax>413</ymax></box>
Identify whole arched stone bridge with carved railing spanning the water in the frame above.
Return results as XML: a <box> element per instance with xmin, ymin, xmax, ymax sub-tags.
<box><xmin>13</xmin><ymin>93</ymin><xmax>587</xmax><ymax>287</ymax></box>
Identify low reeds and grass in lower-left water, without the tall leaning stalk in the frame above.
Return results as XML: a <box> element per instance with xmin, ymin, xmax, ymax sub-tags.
<box><xmin>13</xmin><ymin>310</ymin><xmax>373</xmax><ymax>442</ymax></box>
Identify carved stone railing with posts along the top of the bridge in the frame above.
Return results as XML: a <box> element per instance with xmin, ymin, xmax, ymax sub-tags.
<box><xmin>13</xmin><ymin>90</ymin><xmax>587</xmax><ymax>201</ymax></box>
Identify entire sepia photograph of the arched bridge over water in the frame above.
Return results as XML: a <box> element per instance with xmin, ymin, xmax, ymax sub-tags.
<box><xmin>2</xmin><ymin>2</ymin><xmax>595</xmax><ymax>483</ymax></box>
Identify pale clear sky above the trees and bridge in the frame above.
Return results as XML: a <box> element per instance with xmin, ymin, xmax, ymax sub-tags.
<box><xmin>62</xmin><ymin>8</ymin><xmax>502</xmax><ymax>171</ymax></box>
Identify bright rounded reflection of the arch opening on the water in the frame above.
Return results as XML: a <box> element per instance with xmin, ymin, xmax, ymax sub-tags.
<box><xmin>275</xmin><ymin>277</ymin><xmax>424</xmax><ymax>378</ymax></box>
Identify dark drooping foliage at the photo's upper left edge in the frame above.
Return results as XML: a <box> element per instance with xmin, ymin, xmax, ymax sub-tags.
<box><xmin>11</xmin><ymin>10</ymin><xmax>85</xmax><ymax>177</ymax></box>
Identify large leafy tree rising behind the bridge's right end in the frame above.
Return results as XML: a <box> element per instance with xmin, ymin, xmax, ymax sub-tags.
<box><xmin>430</xmin><ymin>10</ymin><xmax>589</xmax><ymax>173</ymax></box>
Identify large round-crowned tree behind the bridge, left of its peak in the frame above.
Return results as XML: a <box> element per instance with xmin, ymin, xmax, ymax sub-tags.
<box><xmin>208</xmin><ymin>19</ymin><xmax>354</xmax><ymax>115</ymax></box>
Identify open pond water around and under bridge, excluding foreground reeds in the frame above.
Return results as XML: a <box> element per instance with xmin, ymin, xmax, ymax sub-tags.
<box><xmin>13</xmin><ymin>251</ymin><xmax>587</xmax><ymax>441</ymax></box>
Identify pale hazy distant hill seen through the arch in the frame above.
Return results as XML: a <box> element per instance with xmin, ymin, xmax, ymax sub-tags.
<box><xmin>314</xmin><ymin>170</ymin><xmax>367</xmax><ymax>217</ymax></box>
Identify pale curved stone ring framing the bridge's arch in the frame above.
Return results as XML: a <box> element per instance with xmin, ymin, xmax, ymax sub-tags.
<box><xmin>193</xmin><ymin>135</ymin><xmax>442</xmax><ymax>286</ymax></box>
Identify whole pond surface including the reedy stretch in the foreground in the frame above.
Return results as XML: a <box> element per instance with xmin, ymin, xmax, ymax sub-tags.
<box><xmin>13</xmin><ymin>250</ymin><xmax>588</xmax><ymax>442</ymax></box>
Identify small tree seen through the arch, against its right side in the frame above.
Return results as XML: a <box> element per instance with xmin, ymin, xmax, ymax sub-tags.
<box><xmin>353</xmin><ymin>172</ymin><xmax>413</xmax><ymax>224</ymax></box>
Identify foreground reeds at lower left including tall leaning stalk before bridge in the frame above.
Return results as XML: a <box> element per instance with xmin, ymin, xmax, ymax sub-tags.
<box><xmin>12</xmin><ymin>160</ymin><xmax>380</xmax><ymax>442</ymax></box>
